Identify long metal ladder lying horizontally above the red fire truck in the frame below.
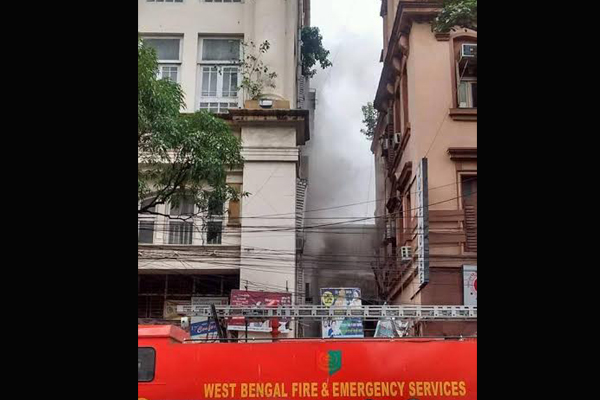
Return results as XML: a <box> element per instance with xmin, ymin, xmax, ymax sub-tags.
<box><xmin>177</xmin><ymin>305</ymin><xmax>477</xmax><ymax>321</ymax></box>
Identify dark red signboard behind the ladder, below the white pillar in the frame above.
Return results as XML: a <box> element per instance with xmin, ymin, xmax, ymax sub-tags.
<box><xmin>227</xmin><ymin>289</ymin><xmax>292</xmax><ymax>333</ymax></box>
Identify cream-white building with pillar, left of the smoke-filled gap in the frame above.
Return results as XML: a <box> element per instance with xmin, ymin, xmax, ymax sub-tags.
<box><xmin>138</xmin><ymin>0</ymin><xmax>310</xmax><ymax>338</ymax></box>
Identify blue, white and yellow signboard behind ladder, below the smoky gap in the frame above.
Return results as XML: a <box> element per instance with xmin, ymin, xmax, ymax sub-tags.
<box><xmin>321</xmin><ymin>288</ymin><xmax>364</xmax><ymax>338</ymax></box>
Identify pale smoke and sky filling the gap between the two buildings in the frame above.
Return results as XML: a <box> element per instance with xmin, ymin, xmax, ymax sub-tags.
<box><xmin>306</xmin><ymin>0</ymin><xmax>382</xmax><ymax>225</ymax></box>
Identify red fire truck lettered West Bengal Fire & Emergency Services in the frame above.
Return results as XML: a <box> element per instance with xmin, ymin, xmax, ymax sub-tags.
<box><xmin>138</xmin><ymin>325</ymin><xmax>477</xmax><ymax>400</ymax></box>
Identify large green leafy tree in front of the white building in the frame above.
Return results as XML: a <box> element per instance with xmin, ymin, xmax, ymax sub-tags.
<box><xmin>138</xmin><ymin>39</ymin><xmax>243</xmax><ymax>213</ymax></box>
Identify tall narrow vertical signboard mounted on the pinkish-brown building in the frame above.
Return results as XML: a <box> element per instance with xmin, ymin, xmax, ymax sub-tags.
<box><xmin>416</xmin><ymin>158</ymin><xmax>429</xmax><ymax>287</ymax></box>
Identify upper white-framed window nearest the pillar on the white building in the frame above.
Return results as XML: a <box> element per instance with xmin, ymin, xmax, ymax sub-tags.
<box><xmin>198</xmin><ymin>38</ymin><xmax>241</xmax><ymax>113</ymax></box>
